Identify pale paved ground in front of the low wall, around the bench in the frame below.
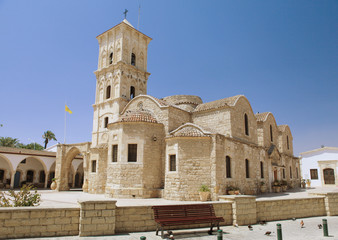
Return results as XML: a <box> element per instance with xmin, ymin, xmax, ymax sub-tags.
<box><xmin>11</xmin><ymin>216</ymin><xmax>338</xmax><ymax>240</ymax></box>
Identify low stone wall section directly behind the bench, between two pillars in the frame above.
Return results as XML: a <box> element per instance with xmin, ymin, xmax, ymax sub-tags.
<box><xmin>115</xmin><ymin>202</ymin><xmax>232</xmax><ymax>233</ymax></box>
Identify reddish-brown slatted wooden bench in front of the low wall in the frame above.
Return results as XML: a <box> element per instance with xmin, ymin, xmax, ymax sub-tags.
<box><xmin>152</xmin><ymin>204</ymin><xmax>224</xmax><ymax>238</ymax></box>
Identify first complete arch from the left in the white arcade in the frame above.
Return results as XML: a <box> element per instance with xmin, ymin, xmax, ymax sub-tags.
<box><xmin>14</xmin><ymin>157</ymin><xmax>46</xmax><ymax>188</ymax></box>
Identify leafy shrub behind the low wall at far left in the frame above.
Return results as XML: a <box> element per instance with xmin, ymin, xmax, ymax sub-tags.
<box><xmin>0</xmin><ymin>185</ymin><xmax>41</xmax><ymax>207</ymax></box>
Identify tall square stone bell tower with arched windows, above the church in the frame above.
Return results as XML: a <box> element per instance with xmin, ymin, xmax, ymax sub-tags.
<box><xmin>92</xmin><ymin>19</ymin><xmax>152</xmax><ymax>147</ymax></box>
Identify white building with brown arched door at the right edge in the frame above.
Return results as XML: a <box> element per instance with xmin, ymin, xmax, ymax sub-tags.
<box><xmin>300</xmin><ymin>147</ymin><xmax>338</xmax><ymax>187</ymax></box>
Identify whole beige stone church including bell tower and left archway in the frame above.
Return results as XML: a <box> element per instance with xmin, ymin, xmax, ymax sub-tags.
<box><xmin>56</xmin><ymin>19</ymin><xmax>300</xmax><ymax>200</ymax></box>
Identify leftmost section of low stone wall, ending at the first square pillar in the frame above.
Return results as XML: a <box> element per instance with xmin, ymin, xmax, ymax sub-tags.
<box><xmin>0</xmin><ymin>207</ymin><xmax>80</xmax><ymax>239</ymax></box>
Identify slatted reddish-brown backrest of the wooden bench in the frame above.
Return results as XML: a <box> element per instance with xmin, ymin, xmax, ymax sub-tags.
<box><xmin>152</xmin><ymin>204</ymin><xmax>215</xmax><ymax>219</ymax></box>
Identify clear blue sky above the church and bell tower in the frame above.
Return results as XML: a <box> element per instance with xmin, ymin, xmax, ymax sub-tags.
<box><xmin>0</xmin><ymin>0</ymin><xmax>338</xmax><ymax>155</ymax></box>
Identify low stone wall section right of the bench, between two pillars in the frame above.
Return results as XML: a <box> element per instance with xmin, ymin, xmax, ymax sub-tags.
<box><xmin>256</xmin><ymin>197</ymin><xmax>326</xmax><ymax>221</ymax></box>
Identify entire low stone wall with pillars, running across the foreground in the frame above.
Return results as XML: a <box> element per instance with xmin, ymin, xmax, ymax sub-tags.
<box><xmin>0</xmin><ymin>193</ymin><xmax>338</xmax><ymax>239</ymax></box>
